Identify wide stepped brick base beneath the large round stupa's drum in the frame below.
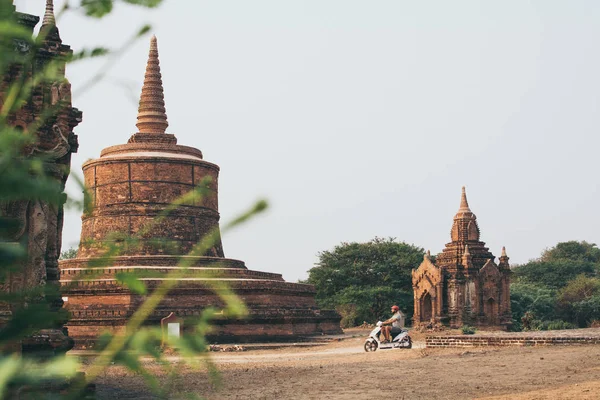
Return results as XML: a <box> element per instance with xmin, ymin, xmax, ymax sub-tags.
<box><xmin>60</xmin><ymin>256</ymin><xmax>341</xmax><ymax>349</ymax></box>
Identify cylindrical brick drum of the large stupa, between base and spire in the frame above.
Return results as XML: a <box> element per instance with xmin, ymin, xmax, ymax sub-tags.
<box><xmin>79</xmin><ymin>155</ymin><xmax>223</xmax><ymax>257</ymax></box>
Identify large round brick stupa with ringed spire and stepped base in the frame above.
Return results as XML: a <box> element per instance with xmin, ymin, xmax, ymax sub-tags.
<box><xmin>60</xmin><ymin>37</ymin><xmax>341</xmax><ymax>348</ymax></box>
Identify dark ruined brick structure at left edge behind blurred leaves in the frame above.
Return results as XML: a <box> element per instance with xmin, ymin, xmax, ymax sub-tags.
<box><xmin>0</xmin><ymin>0</ymin><xmax>81</xmax><ymax>354</ymax></box>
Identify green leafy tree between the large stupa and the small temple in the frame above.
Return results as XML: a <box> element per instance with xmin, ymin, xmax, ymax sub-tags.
<box><xmin>306</xmin><ymin>237</ymin><xmax>424</xmax><ymax>327</ymax></box>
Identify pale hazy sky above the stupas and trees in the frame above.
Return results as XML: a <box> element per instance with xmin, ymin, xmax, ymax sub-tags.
<box><xmin>15</xmin><ymin>0</ymin><xmax>600</xmax><ymax>282</ymax></box>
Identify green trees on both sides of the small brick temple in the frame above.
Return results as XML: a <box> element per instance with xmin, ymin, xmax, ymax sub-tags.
<box><xmin>305</xmin><ymin>238</ymin><xmax>600</xmax><ymax>330</ymax></box>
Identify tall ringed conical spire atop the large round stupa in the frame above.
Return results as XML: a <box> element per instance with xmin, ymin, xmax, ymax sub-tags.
<box><xmin>136</xmin><ymin>36</ymin><xmax>169</xmax><ymax>133</ymax></box>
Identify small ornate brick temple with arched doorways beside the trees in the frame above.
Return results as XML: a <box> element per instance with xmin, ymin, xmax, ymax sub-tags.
<box><xmin>412</xmin><ymin>187</ymin><xmax>512</xmax><ymax>328</ymax></box>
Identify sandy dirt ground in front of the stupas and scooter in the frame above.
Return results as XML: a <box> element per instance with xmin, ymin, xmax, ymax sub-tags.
<box><xmin>90</xmin><ymin>335</ymin><xmax>600</xmax><ymax>400</ymax></box>
